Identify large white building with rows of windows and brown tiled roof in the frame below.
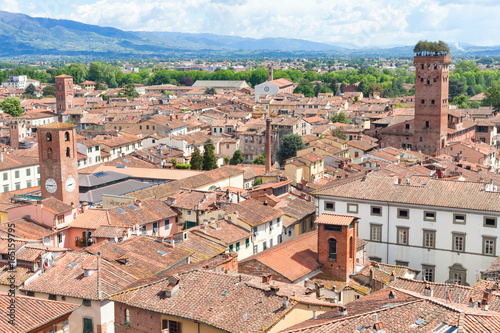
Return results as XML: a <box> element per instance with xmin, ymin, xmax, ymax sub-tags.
<box><xmin>315</xmin><ymin>176</ymin><xmax>500</xmax><ymax>285</ymax></box>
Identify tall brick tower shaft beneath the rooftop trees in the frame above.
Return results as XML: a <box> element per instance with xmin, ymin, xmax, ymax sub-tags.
<box><xmin>413</xmin><ymin>55</ymin><xmax>451</xmax><ymax>155</ymax></box>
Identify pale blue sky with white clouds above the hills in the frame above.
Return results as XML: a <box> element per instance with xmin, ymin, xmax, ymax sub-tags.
<box><xmin>0</xmin><ymin>0</ymin><xmax>500</xmax><ymax>46</ymax></box>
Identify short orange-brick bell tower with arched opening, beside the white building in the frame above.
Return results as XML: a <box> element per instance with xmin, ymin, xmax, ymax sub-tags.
<box><xmin>315</xmin><ymin>213</ymin><xmax>359</xmax><ymax>281</ymax></box>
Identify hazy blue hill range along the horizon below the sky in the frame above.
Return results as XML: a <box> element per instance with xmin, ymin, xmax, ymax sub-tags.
<box><xmin>0</xmin><ymin>11</ymin><xmax>500</xmax><ymax>58</ymax></box>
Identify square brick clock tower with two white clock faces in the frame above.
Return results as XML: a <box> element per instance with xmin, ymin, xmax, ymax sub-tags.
<box><xmin>37</xmin><ymin>122</ymin><xmax>80</xmax><ymax>206</ymax></box>
